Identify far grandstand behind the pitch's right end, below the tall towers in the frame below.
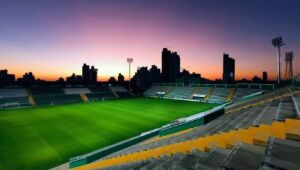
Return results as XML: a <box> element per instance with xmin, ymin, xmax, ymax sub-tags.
<box><xmin>144</xmin><ymin>83</ymin><xmax>274</xmax><ymax>104</ymax></box>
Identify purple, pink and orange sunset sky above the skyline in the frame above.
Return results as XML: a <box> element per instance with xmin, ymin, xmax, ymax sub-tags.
<box><xmin>0</xmin><ymin>0</ymin><xmax>300</xmax><ymax>80</ymax></box>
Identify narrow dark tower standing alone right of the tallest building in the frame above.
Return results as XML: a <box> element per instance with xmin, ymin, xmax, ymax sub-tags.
<box><xmin>223</xmin><ymin>53</ymin><xmax>235</xmax><ymax>83</ymax></box>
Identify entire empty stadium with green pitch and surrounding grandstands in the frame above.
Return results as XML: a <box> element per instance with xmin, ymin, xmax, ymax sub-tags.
<box><xmin>0</xmin><ymin>81</ymin><xmax>300</xmax><ymax>169</ymax></box>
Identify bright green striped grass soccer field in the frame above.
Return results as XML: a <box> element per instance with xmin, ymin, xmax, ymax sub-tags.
<box><xmin>0</xmin><ymin>98</ymin><xmax>216</xmax><ymax>170</ymax></box>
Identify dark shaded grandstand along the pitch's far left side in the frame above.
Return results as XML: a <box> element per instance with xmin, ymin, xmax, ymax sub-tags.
<box><xmin>0</xmin><ymin>85</ymin><xmax>127</xmax><ymax>108</ymax></box>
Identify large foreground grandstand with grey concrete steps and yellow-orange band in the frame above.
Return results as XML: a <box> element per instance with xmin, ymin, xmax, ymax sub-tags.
<box><xmin>70</xmin><ymin>87</ymin><xmax>300</xmax><ymax>170</ymax></box>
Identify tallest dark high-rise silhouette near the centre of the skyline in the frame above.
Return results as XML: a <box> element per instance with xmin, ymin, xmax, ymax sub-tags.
<box><xmin>162</xmin><ymin>48</ymin><xmax>180</xmax><ymax>83</ymax></box>
